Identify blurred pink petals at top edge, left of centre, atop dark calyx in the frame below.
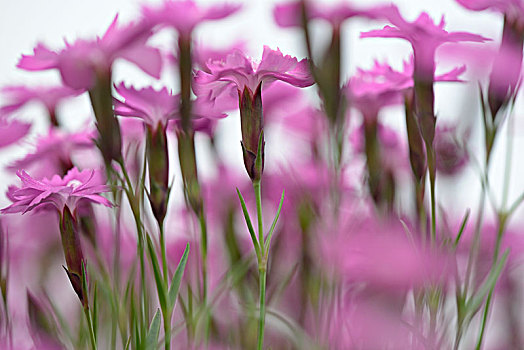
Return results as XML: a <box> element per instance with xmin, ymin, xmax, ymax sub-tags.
<box><xmin>142</xmin><ymin>0</ymin><xmax>242</xmax><ymax>36</ymax></box>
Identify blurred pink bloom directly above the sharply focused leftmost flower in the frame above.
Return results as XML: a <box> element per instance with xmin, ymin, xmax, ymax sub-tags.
<box><xmin>8</xmin><ymin>129</ymin><xmax>96</xmax><ymax>178</ymax></box>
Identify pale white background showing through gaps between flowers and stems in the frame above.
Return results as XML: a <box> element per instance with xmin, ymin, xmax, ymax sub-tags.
<box><xmin>0</xmin><ymin>0</ymin><xmax>524</xmax><ymax>222</ymax></box>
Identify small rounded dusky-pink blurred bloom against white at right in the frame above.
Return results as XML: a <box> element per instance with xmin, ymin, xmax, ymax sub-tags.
<box><xmin>433</xmin><ymin>126</ymin><xmax>469</xmax><ymax>175</ymax></box>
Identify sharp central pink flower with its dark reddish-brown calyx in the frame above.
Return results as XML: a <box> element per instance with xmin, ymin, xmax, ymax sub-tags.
<box><xmin>194</xmin><ymin>46</ymin><xmax>314</xmax><ymax>180</ymax></box>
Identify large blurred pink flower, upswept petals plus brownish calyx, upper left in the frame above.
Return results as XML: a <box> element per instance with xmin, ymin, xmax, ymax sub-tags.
<box><xmin>18</xmin><ymin>15</ymin><xmax>162</xmax><ymax>168</ymax></box>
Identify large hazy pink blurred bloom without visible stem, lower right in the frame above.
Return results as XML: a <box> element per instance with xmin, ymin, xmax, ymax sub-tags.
<box><xmin>320</xmin><ymin>216</ymin><xmax>451</xmax><ymax>290</ymax></box>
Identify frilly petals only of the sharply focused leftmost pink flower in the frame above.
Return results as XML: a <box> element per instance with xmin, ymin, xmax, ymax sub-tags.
<box><xmin>1</xmin><ymin>168</ymin><xmax>112</xmax><ymax>214</ymax></box>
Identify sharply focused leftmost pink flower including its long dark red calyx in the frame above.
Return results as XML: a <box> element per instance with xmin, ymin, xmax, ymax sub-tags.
<box><xmin>1</xmin><ymin>168</ymin><xmax>112</xmax><ymax>310</ymax></box>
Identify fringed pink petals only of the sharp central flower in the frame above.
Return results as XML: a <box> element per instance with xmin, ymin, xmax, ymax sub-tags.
<box><xmin>193</xmin><ymin>46</ymin><xmax>314</xmax><ymax>101</ymax></box>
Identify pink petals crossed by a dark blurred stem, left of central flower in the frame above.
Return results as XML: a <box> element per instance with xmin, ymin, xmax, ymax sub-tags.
<box><xmin>115</xmin><ymin>83</ymin><xmax>226</xmax><ymax>129</ymax></box>
